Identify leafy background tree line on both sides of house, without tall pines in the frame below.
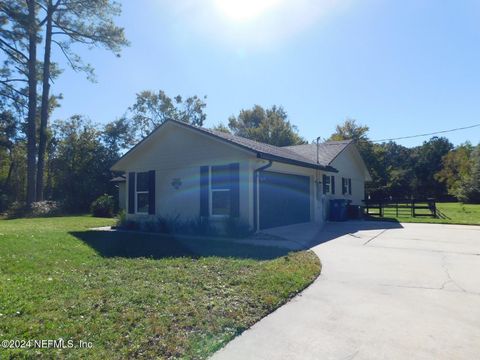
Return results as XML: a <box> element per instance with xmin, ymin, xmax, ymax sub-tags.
<box><xmin>0</xmin><ymin>87</ymin><xmax>480</xmax><ymax>211</ymax></box>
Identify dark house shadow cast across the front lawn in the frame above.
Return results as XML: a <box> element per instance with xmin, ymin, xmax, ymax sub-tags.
<box><xmin>70</xmin><ymin>230</ymin><xmax>289</xmax><ymax>260</ymax></box>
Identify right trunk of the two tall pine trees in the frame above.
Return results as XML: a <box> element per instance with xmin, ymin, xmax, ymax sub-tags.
<box><xmin>37</xmin><ymin>0</ymin><xmax>53</xmax><ymax>201</ymax></box>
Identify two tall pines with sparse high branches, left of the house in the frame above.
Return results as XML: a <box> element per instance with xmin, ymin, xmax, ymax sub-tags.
<box><xmin>0</xmin><ymin>0</ymin><xmax>128</xmax><ymax>205</ymax></box>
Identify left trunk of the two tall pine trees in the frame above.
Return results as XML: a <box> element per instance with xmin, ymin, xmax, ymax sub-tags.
<box><xmin>27</xmin><ymin>0</ymin><xmax>37</xmax><ymax>205</ymax></box>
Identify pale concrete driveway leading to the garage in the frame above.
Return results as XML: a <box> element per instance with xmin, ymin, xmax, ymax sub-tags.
<box><xmin>213</xmin><ymin>222</ymin><xmax>480</xmax><ymax>360</ymax></box>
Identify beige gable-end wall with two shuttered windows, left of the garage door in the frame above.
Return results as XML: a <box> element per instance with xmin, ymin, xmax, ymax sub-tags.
<box><xmin>120</xmin><ymin>124</ymin><xmax>253</xmax><ymax>223</ymax></box>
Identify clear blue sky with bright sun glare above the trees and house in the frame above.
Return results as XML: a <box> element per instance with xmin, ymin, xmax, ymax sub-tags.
<box><xmin>52</xmin><ymin>0</ymin><xmax>480</xmax><ymax>146</ymax></box>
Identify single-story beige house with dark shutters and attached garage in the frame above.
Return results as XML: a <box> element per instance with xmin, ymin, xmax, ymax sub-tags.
<box><xmin>111</xmin><ymin>120</ymin><xmax>370</xmax><ymax>231</ymax></box>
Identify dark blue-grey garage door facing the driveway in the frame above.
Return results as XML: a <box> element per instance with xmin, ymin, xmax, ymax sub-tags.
<box><xmin>260</xmin><ymin>171</ymin><xmax>310</xmax><ymax>229</ymax></box>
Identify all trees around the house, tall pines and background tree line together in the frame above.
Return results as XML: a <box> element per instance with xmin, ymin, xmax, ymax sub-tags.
<box><xmin>0</xmin><ymin>0</ymin><xmax>480</xmax><ymax>211</ymax></box>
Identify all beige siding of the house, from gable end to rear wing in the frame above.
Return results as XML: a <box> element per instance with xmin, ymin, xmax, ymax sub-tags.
<box><xmin>113</xmin><ymin>123</ymin><xmax>365</xmax><ymax>231</ymax></box>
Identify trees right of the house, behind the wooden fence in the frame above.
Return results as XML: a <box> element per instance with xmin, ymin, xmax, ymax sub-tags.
<box><xmin>330</xmin><ymin>119</ymin><xmax>480</xmax><ymax>203</ymax></box>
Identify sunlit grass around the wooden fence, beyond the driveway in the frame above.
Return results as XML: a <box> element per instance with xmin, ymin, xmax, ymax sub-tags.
<box><xmin>370</xmin><ymin>203</ymin><xmax>480</xmax><ymax>225</ymax></box>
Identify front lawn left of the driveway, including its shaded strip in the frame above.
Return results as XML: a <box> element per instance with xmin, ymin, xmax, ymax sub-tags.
<box><xmin>0</xmin><ymin>216</ymin><xmax>321</xmax><ymax>359</ymax></box>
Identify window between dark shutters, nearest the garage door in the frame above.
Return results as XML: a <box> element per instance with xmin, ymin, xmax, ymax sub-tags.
<box><xmin>210</xmin><ymin>165</ymin><xmax>231</xmax><ymax>216</ymax></box>
